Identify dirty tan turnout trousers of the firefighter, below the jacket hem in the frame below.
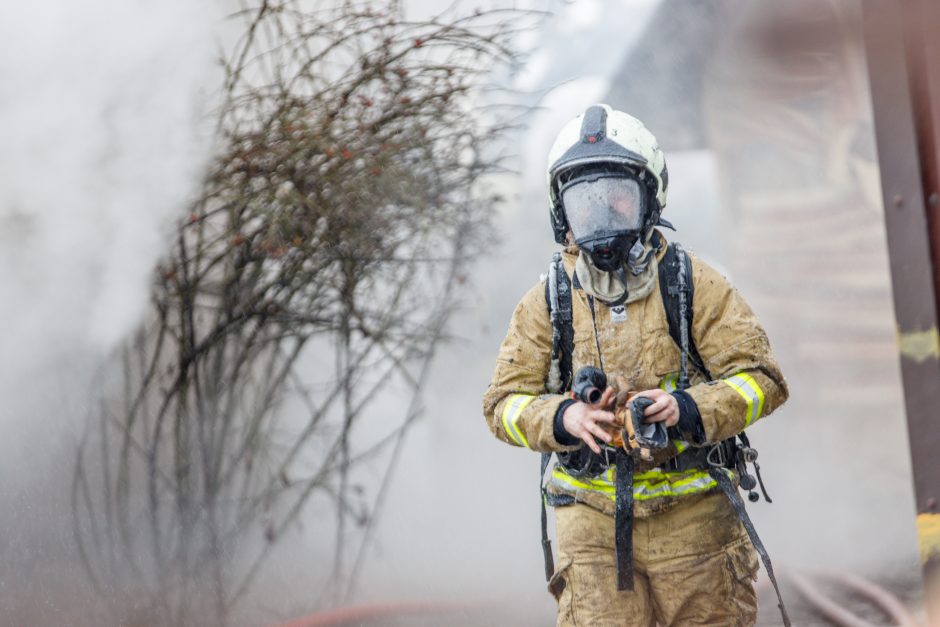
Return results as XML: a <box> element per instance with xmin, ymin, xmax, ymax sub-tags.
<box><xmin>549</xmin><ymin>492</ymin><xmax>758</xmax><ymax>627</ymax></box>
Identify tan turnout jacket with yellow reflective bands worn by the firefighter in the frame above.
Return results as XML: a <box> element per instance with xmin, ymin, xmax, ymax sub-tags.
<box><xmin>483</xmin><ymin>238</ymin><xmax>787</xmax><ymax>517</ymax></box>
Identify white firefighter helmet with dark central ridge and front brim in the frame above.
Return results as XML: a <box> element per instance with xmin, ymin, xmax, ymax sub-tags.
<box><xmin>548</xmin><ymin>104</ymin><xmax>669</xmax><ymax>244</ymax></box>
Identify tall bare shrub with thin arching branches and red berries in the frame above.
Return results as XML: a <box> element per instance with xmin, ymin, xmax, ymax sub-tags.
<box><xmin>73</xmin><ymin>0</ymin><xmax>521</xmax><ymax>624</ymax></box>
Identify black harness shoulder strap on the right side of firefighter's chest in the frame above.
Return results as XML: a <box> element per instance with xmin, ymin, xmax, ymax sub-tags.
<box><xmin>659</xmin><ymin>242</ymin><xmax>712</xmax><ymax>387</ymax></box>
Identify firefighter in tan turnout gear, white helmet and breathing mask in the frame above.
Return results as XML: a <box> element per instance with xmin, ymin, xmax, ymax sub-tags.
<box><xmin>483</xmin><ymin>105</ymin><xmax>788</xmax><ymax>626</ymax></box>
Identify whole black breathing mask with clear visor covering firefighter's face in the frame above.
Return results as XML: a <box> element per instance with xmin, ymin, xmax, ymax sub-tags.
<box><xmin>559</xmin><ymin>169</ymin><xmax>647</xmax><ymax>272</ymax></box>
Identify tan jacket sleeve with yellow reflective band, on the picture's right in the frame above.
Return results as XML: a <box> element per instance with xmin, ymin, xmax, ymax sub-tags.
<box><xmin>686</xmin><ymin>256</ymin><xmax>789</xmax><ymax>442</ymax></box>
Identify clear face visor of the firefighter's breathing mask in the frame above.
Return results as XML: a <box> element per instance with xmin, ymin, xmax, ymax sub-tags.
<box><xmin>561</xmin><ymin>176</ymin><xmax>643</xmax><ymax>241</ymax></box>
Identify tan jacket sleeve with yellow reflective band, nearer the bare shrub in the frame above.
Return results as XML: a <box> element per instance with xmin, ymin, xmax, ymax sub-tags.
<box><xmin>483</xmin><ymin>282</ymin><xmax>578</xmax><ymax>452</ymax></box>
